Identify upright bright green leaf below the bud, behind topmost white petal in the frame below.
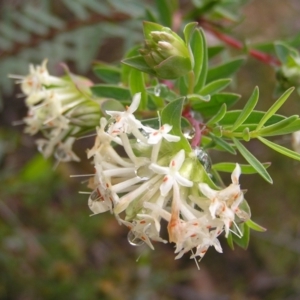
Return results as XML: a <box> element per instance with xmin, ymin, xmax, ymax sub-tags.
<box><xmin>129</xmin><ymin>69</ymin><xmax>148</xmax><ymax>110</ymax></box>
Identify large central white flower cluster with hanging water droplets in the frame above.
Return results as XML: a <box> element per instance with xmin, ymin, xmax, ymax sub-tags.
<box><xmin>88</xmin><ymin>94</ymin><xmax>249</xmax><ymax>259</ymax></box>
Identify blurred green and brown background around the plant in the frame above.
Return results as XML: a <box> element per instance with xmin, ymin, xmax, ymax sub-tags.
<box><xmin>0</xmin><ymin>0</ymin><xmax>300</xmax><ymax>300</ymax></box>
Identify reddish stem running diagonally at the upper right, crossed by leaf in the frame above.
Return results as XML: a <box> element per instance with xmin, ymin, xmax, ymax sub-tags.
<box><xmin>199</xmin><ymin>19</ymin><xmax>281</xmax><ymax>66</ymax></box>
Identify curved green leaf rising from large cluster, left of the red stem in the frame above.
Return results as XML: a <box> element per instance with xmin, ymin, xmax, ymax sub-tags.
<box><xmin>161</xmin><ymin>97</ymin><xmax>192</xmax><ymax>152</ymax></box>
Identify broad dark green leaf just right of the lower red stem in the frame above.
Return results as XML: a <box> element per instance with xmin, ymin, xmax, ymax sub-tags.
<box><xmin>191</xmin><ymin>93</ymin><xmax>240</xmax><ymax>117</ymax></box>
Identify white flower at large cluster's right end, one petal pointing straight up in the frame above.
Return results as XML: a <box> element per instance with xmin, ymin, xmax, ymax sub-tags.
<box><xmin>199</xmin><ymin>164</ymin><xmax>244</xmax><ymax>237</ymax></box>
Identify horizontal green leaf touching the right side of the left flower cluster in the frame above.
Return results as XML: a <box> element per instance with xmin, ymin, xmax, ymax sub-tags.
<box><xmin>91</xmin><ymin>84</ymin><xmax>131</xmax><ymax>101</ymax></box>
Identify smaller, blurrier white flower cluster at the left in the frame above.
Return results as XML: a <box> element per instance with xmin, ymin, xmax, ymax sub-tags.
<box><xmin>10</xmin><ymin>60</ymin><xmax>99</xmax><ymax>161</ymax></box>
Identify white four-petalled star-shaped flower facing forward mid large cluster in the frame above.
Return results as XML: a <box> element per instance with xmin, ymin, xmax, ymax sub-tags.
<box><xmin>149</xmin><ymin>150</ymin><xmax>193</xmax><ymax>196</ymax></box>
